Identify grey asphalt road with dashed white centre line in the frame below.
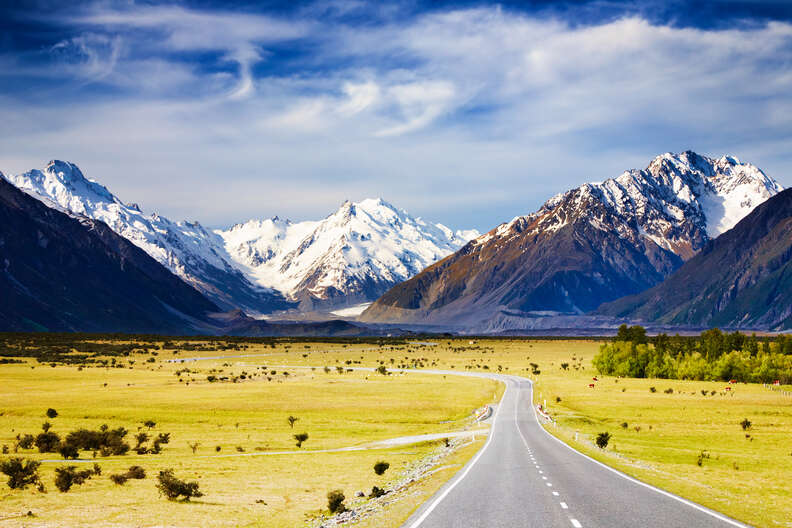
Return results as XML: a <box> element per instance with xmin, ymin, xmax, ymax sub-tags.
<box><xmin>403</xmin><ymin>373</ymin><xmax>746</xmax><ymax>528</ymax></box>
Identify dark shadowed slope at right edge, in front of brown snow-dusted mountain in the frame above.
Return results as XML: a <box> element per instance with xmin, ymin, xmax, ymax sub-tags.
<box><xmin>597</xmin><ymin>189</ymin><xmax>792</xmax><ymax>330</ymax></box>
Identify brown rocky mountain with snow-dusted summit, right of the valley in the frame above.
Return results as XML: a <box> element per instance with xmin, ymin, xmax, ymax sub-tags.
<box><xmin>361</xmin><ymin>151</ymin><xmax>781</xmax><ymax>327</ymax></box>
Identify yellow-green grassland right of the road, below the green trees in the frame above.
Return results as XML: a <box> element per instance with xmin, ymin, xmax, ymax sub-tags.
<box><xmin>266</xmin><ymin>339</ymin><xmax>792</xmax><ymax>527</ymax></box>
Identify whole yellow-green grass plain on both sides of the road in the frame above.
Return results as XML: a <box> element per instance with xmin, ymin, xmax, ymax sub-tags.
<box><xmin>0</xmin><ymin>339</ymin><xmax>792</xmax><ymax>527</ymax></box>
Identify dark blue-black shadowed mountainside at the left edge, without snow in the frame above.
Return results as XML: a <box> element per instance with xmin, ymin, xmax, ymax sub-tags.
<box><xmin>0</xmin><ymin>177</ymin><xmax>217</xmax><ymax>334</ymax></box>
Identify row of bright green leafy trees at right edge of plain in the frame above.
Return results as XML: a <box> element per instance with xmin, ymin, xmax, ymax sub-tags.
<box><xmin>593</xmin><ymin>325</ymin><xmax>792</xmax><ymax>384</ymax></box>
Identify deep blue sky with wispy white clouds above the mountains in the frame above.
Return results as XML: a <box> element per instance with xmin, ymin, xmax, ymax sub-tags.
<box><xmin>0</xmin><ymin>0</ymin><xmax>792</xmax><ymax>230</ymax></box>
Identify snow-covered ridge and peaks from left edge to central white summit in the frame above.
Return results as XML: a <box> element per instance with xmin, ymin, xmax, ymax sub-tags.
<box><xmin>3</xmin><ymin>161</ymin><xmax>478</xmax><ymax>315</ymax></box>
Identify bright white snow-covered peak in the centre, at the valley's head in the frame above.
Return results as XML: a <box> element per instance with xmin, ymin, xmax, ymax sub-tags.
<box><xmin>218</xmin><ymin>199</ymin><xmax>478</xmax><ymax>308</ymax></box>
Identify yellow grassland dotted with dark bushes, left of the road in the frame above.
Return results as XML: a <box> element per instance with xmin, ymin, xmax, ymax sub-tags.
<box><xmin>0</xmin><ymin>345</ymin><xmax>500</xmax><ymax>527</ymax></box>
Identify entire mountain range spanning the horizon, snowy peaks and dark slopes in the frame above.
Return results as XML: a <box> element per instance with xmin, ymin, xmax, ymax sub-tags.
<box><xmin>0</xmin><ymin>151</ymin><xmax>792</xmax><ymax>336</ymax></box>
